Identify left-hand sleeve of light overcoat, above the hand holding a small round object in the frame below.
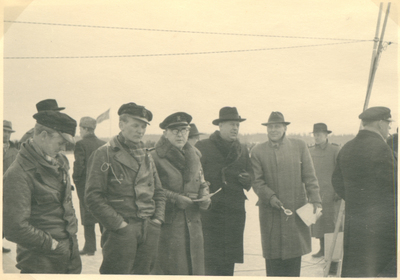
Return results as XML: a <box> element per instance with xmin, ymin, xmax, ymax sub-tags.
<box><xmin>250</xmin><ymin>148</ymin><xmax>275</xmax><ymax>203</ymax></box>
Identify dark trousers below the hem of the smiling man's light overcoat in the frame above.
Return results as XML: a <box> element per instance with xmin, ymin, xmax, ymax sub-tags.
<box><xmin>265</xmin><ymin>257</ymin><xmax>301</xmax><ymax>277</ymax></box>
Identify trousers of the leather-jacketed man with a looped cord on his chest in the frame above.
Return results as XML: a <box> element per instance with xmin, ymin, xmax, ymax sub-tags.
<box><xmin>100</xmin><ymin>219</ymin><xmax>161</xmax><ymax>274</ymax></box>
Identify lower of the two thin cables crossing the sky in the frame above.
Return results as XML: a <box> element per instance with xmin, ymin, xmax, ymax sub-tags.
<box><xmin>4</xmin><ymin>41</ymin><xmax>364</xmax><ymax>59</ymax></box>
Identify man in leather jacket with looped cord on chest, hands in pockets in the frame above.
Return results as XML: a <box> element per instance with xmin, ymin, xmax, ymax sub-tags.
<box><xmin>85</xmin><ymin>102</ymin><xmax>166</xmax><ymax>274</ymax></box>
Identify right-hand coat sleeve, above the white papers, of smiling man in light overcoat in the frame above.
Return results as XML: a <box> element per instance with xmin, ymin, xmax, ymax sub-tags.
<box><xmin>299</xmin><ymin>141</ymin><xmax>321</xmax><ymax>203</ymax></box>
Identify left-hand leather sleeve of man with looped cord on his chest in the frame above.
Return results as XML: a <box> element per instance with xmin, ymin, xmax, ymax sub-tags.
<box><xmin>85</xmin><ymin>146</ymin><xmax>124</xmax><ymax>230</ymax></box>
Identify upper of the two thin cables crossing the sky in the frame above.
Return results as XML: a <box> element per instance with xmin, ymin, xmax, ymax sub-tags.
<box><xmin>4</xmin><ymin>20</ymin><xmax>371</xmax><ymax>41</ymax></box>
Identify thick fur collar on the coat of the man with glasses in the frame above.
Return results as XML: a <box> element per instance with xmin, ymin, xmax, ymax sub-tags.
<box><xmin>156</xmin><ymin>136</ymin><xmax>198</xmax><ymax>183</ymax></box>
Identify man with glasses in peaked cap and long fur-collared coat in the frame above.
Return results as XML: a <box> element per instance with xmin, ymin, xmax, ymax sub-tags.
<box><xmin>151</xmin><ymin>112</ymin><xmax>211</xmax><ymax>275</ymax></box>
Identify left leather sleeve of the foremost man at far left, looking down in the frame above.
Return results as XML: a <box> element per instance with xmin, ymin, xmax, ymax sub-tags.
<box><xmin>3</xmin><ymin>169</ymin><xmax>52</xmax><ymax>251</ymax></box>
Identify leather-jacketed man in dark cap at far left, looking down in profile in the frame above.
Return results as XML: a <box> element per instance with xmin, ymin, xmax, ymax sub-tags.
<box><xmin>3</xmin><ymin>111</ymin><xmax>82</xmax><ymax>274</ymax></box>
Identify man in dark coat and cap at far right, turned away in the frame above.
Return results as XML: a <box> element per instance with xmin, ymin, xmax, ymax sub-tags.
<box><xmin>332</xmin><ymin>107</ymin><xmax>397</xmax><ymax>277</ymax></box>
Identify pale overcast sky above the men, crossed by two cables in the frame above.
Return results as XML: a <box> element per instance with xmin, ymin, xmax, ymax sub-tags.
<box><xmin>3</xmin><ymin>0</ymin><xmax>399</xmax><ymax>139</ymax></box>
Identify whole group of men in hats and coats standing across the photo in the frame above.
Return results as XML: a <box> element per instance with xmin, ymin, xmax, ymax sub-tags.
<box><xmin>3</xmin><ymin>99</ymin><xmax>398</xmax><ymax>277</ymax></box>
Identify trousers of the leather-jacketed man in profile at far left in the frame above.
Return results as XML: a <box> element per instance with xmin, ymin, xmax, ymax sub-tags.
<box><xmin>17</xmin><ymin>236</ymin><xmax>82</xmax><ymax>274</ymax></box>
